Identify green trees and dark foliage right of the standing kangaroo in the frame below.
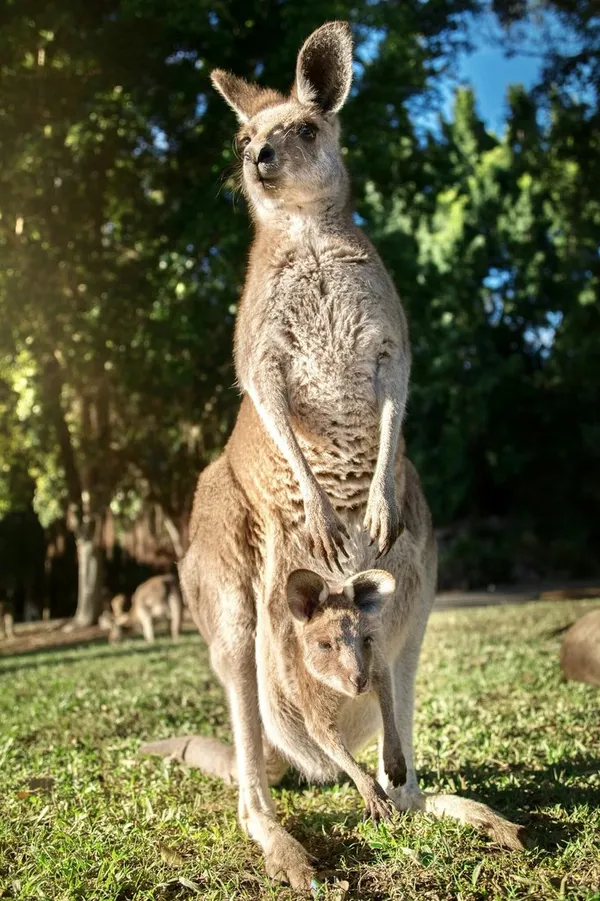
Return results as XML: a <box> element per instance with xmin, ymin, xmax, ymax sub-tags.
<box><xmin>370</xmin><ymin>81</ymin><xmax>600</xmax><ymax>584</ymax></box>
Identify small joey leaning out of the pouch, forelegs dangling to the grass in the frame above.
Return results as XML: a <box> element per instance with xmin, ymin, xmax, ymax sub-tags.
<box><xmin>286</xmin><ymin>570</ymin><xmax>406</xmax><ymax>820</ymax></box>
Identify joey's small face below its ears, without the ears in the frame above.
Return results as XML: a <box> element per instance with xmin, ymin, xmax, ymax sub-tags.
<box><xmin>301</xmin><ymin>595</ymin><xmax>378</xmax><ymax>698</ymax></box>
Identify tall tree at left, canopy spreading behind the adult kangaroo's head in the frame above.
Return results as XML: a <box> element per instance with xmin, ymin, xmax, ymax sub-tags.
<box><xmin>0</xmin><ymin>0</ymin><xmax>478</xmax><ymax>624</ymax></box>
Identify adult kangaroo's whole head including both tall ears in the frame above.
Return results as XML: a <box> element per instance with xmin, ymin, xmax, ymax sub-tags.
<box><xmin>211</xmin><ymin>22</ymin><xmax>352</xmax><ymax>221</ymax></box>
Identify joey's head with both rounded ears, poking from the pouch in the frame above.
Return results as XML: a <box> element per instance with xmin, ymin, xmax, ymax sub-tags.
<box><xmin>287</xmin><ymin>569</ymin><xmax>396</xmax><ymax>697</ymax></box>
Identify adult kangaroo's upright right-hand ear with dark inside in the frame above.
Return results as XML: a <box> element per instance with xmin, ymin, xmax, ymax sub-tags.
<box><xmin>294</xmin><ymin>22</ymin><xmax>352</xmax><ymax>113</ymax></box>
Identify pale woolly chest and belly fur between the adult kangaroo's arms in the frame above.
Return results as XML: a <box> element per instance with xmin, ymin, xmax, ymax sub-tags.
<box><xmin>274</xmin><ymin>253</ymin><xmax>389</xmax><ymax>508</ymax></box>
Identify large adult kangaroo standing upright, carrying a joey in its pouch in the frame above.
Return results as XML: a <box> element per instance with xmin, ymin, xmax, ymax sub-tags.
<box><xmin>142</xmin><ymin>22</ymin><xmax>520</xmax><ymax>889</ymax></box>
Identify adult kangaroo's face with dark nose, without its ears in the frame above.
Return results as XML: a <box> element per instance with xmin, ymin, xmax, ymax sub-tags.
<box><xmin>237</xmin><ymin>101</ymin><xmax>347</xmax><ymax>218</ymax></box>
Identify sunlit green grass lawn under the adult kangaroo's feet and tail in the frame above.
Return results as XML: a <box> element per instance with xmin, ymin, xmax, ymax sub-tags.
<box><xmin>0</xmin><ymin>602</ymin><xmax>600</xmax><ymax>901</ymax></box>
